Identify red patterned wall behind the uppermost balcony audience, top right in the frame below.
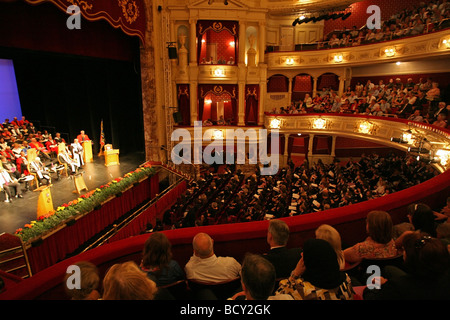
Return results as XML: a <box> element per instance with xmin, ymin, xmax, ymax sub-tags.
<box><xmin>323</xmin><ymin>0</ymin><xmax>425</xmax><ymax>36</ymax></box>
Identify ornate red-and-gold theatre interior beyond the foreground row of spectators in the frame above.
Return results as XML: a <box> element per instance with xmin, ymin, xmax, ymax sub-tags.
<box><xmin>0</xmin><ymin>0</ymin><xmax>450</xmax><ymax>300</ymax></box>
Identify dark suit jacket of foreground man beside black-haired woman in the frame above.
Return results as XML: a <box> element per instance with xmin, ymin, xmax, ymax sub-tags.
<box><xmin>263</xmin><ymin>247</ymin><xmax>302</xmax><ymax>278</ymax></box>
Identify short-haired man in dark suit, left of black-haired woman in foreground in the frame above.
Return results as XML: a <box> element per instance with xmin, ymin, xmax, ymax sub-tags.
<box><xmin>263</xmin><ymin>219</ymin><xmax>302</xmax><ymax>278</ymax></box>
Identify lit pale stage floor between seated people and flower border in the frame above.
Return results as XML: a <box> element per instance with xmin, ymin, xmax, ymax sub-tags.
<box><xmin>0</xmin><ymin>152</ymin><xmax>145</xmax><ymax>233</ymax></box>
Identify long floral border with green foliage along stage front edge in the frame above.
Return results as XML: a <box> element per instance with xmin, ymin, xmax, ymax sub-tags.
<box><xmin>14</xmin><ymin>163</ymin><xmax>156</xmax><ymax>242</ymax></box>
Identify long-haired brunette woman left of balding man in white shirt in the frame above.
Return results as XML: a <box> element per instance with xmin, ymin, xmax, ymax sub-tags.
<box><xmin>139</xmin><ymin>232</ymin><xmax>184</xmax><ymax>287</ymax></box>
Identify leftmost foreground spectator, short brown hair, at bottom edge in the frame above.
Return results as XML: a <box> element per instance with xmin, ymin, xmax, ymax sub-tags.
<box><xmin>64</xmin><ymin>261</ymin><xmax>101</xmax><ymax>300</ymax></box>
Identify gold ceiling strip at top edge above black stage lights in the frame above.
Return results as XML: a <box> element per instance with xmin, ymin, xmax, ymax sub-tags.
<box><xmin>267</xmin><ymin>0</ymin><xmax>358</xmax><ymax>16</ymax></box>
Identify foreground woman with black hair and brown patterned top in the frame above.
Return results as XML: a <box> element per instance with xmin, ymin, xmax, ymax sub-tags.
<box><xmin>275</xmin><ymin>239</ymin><xmax>353</xmax><ymax>300</ymax></box>
